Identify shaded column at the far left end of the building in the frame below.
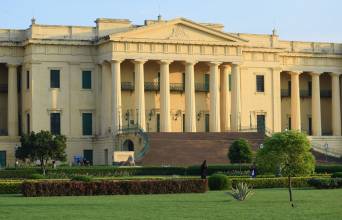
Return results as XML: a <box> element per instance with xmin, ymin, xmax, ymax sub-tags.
<box><xmin>7</xmin><ymin>64</ymin><xmax>19</xmax><ymax>136</ymax></box>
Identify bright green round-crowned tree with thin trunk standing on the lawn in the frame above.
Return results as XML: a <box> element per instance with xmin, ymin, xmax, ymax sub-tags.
<box><xmin>256</xmin><ymin>131</ymin><xmax>315</xmax><ymax>207</ymax></box>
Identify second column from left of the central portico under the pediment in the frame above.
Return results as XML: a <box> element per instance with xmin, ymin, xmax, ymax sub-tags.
<box><xmin>134</xmin><ymin>60</ymin><xmax>146</xmax><ymax>131</ymax></box>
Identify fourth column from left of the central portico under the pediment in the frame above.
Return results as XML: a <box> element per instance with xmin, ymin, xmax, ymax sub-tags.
<box><xmin>185</xmin><ymin>62</ymin><xmax>196</xmax><ymax>132</ymax></box>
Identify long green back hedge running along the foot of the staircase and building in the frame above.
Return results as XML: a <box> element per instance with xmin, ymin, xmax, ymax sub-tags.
<box><xmin>0</xmin><ymin>164</ymin><xmax>342</xmax><ymax>179</ymax></box>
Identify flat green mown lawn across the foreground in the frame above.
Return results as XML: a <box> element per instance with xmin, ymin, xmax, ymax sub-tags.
<box><xmin>0</xmin><ymin>189</ymin><xmax>342</xmax><ymax>220</ymax></box>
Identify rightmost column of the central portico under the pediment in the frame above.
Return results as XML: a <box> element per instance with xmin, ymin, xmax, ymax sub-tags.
<box><xmin>230</xmin><ymin>63</ymin><xmax>240</xmax><ymax>131</ymax></box>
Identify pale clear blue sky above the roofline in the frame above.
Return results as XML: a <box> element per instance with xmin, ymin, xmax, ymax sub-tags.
<box><xmin>0</xmin><ymin>0</ymin><xmax>342</xmax><ymax>43</ymax></box>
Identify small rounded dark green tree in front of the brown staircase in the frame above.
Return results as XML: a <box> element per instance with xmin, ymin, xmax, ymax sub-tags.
<box><xmin>228</xmin><ymin>139</ymin><xmax>252</xmax><ymax>164</ymax></box>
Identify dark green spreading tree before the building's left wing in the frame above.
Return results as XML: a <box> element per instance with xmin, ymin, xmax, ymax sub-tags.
<box><xmin>15</xmin><ymin>131</ymin><xmax>66</xmax><ymax>175</ymax></box>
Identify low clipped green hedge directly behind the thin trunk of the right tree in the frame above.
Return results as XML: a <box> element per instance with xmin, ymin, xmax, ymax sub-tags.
<box><xmin>231</xmin><ymin>177</ymin><xmax>330</xmax><ymax>189</ymax></box>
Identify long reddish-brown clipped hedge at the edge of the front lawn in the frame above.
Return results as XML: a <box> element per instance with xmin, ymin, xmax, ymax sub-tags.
<box><xmin>22</xmin><ymin>179</ymin><xmax>208</xmax><ymax>197</ymax></box>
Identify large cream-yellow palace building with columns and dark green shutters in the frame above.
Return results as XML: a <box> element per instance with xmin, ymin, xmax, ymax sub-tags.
<box><xmin>0</xmin><ymin>16</ymin><xmax>342</xmax><ymax>166</ymax></box>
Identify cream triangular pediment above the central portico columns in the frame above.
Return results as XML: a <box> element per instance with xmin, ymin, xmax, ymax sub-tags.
<box><xmin>110</xmin><ymin>18</ymin><xmax>246</xmax><ymax>44</ymax></box>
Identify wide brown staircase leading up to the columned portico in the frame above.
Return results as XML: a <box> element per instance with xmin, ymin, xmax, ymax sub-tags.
<box><xmin>137</xmin><ymin>132</ymin><xmax>265</xmax><ymax>166</ymax></box>
